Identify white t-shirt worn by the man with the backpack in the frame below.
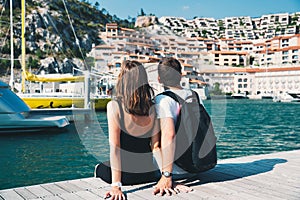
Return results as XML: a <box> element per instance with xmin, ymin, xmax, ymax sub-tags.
<box><xmin>155</xmin><ymin>89</ymin><xmax>203</xmax><ymax>174</ymax></box>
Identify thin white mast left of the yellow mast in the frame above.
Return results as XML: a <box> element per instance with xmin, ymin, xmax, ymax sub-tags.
<box><xmin>9</xmin><ymin>0</ymin><xmax>14</xmax><ymax>90</ymax></box>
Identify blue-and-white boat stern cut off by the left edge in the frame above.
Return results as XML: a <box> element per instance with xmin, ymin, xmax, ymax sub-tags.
<box><xmin>0</xmin><ymin>81</ymin><xmax>69</xmax><ymax>133</ymax></box>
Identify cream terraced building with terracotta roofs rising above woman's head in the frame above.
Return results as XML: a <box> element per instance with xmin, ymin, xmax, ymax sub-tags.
<box><xmin>89</xmin><ymin>23</ymin><xmax>156</xmax><ymax>72</ymax></box>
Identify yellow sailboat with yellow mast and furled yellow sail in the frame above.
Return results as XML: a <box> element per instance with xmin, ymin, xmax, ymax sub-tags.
<box><xmin>12</xmin><ymin>0</ymin><xmax>111</xmax><ymax>110</ymax></box>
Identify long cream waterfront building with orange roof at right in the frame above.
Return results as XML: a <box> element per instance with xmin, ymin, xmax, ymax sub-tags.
<box><xmin>202</xmin><ymin>67</ymin><xmax>300</xmax><ymax>98</ymax></box>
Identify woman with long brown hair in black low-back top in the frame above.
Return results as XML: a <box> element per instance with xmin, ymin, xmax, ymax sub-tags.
<box><xmin>95</xmin><ymin>61</ymin><xmax>160</xmax><ymax>199</ymax></box>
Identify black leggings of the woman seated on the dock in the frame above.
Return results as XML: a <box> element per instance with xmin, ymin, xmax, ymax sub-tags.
<box><xmin>95</xmin><ymin>161</ymin><xmax>160</xmax><ymax>185</ymax></box>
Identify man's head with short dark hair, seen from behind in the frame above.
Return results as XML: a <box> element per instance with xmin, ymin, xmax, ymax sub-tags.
<box><xmin>158</xmin><ymin>57</ymin><xmax>181</xmax><ymax>86</ymax></box>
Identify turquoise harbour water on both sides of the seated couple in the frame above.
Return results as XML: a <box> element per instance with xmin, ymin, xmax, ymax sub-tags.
<box><xmin>0</xmin><ymin>99</ymin><xmax>300</xmax><ymax>189</ymax></box>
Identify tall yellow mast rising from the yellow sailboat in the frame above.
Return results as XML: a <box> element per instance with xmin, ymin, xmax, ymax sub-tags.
<box><xmin>21</xmin><ymin>0</ymin><xmax>26</xmax><ymax>93</ymax></box>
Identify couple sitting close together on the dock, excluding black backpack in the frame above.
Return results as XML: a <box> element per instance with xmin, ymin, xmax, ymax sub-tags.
<box><xmin>95</xmin><ymin>58</ymin><xmax>197</xmax><ymax>199</ymax></box>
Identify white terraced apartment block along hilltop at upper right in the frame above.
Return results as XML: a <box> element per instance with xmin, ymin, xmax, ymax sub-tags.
<box><xmin>159</xmin><ymin>12</ymin><xmax>300</xmax><ymax>40</ymax></box>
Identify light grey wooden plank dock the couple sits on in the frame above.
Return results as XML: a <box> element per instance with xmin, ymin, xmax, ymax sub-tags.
<box><xmin>0</xmin><ymin>150</ymin><xmax>300</xmax><ymax>200</ymax></box>
